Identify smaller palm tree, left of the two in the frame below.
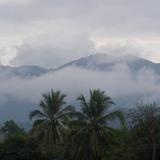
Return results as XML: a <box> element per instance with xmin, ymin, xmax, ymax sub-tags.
<box><xmin>29</xmin><ymin>90</ymin><xmax>73</xmax><ymax>148</ymax></box>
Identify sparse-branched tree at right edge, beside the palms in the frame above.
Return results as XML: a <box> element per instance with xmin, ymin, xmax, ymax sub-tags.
<box><xmin>125</xmin><ymin>103</ymin><xmax>160</xmax><ymax>160</ymax></box>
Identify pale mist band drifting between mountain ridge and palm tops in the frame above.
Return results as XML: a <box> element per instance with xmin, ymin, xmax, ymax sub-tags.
<box><xmin>0</xmin><ymin>63</ymin><xmax>160</xmax><ymax>105</ymax></box>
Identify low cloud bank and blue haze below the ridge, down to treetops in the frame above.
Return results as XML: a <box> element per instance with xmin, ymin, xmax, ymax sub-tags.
<box><xmin>0</xmin><ymin>64</ymin><xmax>160</xmax><ymax>121</ymax></box>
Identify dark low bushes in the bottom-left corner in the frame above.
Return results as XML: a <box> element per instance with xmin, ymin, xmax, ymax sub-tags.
<box><xmin>0</xmin><ymin>136</ymin><xmax>44</xmax><ymax>160</ymax></box>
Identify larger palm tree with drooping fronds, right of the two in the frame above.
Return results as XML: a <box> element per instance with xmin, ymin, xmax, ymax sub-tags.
<box><xmin>67</xmin><ymin>89</ymin><xmax>122</xmax><ymax>160</ymax></box>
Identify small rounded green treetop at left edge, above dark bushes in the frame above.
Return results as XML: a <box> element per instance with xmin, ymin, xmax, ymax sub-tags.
<box><xmin>0</xmin><ymin>119</ymin><xmax>27</xmax><ymax>137</ymax></box>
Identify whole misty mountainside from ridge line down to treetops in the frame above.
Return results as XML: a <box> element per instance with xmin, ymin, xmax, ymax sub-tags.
<box><xmin>0</xmin><ymin>53</ymin><xmax>160</xmax><ymax>123</ymax></box>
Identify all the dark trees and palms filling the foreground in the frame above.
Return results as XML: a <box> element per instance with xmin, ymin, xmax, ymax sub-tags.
<box><xmin>0</xmin><ymin>89</ymin><xmax>160</xmax><ymax>160</ymax></box>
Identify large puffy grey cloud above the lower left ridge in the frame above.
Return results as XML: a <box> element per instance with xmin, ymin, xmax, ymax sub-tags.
<box><xmin>10</xmin><ymin>33</ymin><xmax>95</xmax><ymax>68</ymax></box>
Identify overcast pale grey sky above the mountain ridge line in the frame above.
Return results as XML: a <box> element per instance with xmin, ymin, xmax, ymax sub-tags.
<box><xmin>0</xmin><ymin>0</ymin><xmax>160</xmax><ymax>68</ymax></box>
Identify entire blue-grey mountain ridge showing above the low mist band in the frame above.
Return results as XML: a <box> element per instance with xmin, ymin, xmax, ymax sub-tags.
<box><xmin>0</xmin><ymin>53</ymin><xmax>160</xmax><ymax>79</ymax></box>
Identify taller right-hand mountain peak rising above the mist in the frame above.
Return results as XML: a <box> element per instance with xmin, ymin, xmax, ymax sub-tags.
<box><xmin>58</xmin><ymin>53</ymin><xmax>160</xmax><ymax>75</ymax></box>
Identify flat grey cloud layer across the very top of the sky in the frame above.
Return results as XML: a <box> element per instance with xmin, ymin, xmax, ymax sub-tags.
<box><xmin>0</xmin><ymin>0</ymin><xmax>160</xmax><ymax>36</ymax></box>
